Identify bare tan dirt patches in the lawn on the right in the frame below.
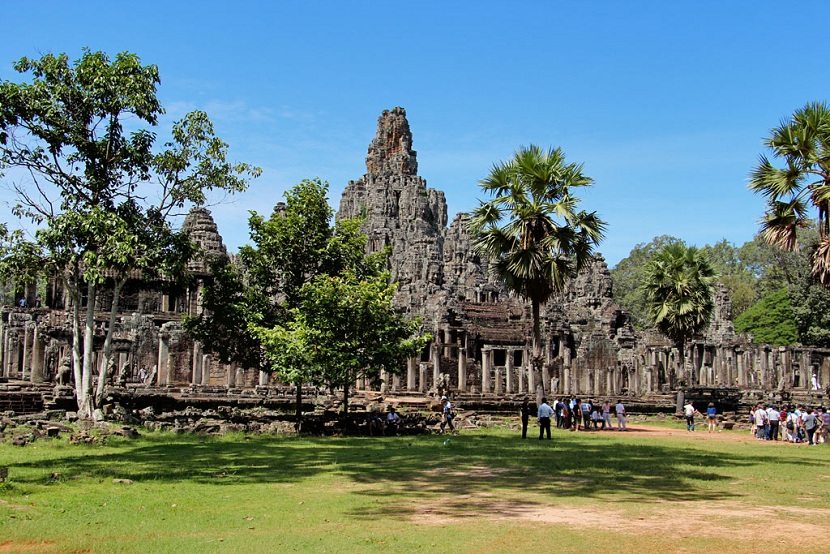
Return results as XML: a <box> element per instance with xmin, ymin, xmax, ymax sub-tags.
<box><xmin>411</xmin><ymin>424</ymin><xmax>830</xmax><ymax>552</ymax></box>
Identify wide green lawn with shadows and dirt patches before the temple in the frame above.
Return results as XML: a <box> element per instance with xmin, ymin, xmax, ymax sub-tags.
<box><xmin>0</xmin><ymin>424</ymin><xmax>830</xmax><ymax>553</ymax></box>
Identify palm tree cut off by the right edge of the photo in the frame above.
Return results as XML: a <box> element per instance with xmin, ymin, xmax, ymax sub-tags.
<box><xmin>749</xmin><ymin>102</ymin><xmax>830</xmax><ymax>288</ymax></box>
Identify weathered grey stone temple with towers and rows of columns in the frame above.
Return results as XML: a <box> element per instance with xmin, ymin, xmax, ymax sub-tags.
<box><xmin>0</xmin><ymin>108</ymin><xmax>830</xmax><ymax>410</ymax></box>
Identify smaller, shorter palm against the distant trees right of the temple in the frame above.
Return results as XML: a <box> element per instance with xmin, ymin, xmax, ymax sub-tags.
<box><xmin>642</xmin><ymin>243</ymin><xmax>715</xmax><ymax>384</ymax></box>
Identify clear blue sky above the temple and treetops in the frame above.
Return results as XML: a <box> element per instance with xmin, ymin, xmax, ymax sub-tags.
<box><xmin>0</xmin><ymin>0</ymin><xmax>830</xmax><ymax>266</ymax></box>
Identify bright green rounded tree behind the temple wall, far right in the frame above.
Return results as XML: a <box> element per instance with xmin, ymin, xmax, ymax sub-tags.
<box><xmin>735</xmin><ymin>289</ymin><xmax>798</xmax><ymax>346</ymax></box>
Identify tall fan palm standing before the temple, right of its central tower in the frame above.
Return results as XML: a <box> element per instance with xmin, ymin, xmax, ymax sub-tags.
<box><xmin>470</xmin><ymin>145</ymin><xmax>605</xmax><ymax>390</ymax></box>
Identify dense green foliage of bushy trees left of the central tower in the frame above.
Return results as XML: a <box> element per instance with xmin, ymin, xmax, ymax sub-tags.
<box><xmin>186</xmin><ymin>180</ymin><xmax>429</xmax><ymax>410</ymax></box>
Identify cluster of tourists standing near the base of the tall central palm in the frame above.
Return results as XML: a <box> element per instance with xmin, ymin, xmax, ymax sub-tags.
<box><xmin>520</xmin><ymin>396</ymin><xmax>627</xmax><ymax>440</ymax></box>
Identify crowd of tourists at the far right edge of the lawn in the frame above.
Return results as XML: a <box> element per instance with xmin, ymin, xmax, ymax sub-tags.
<box><xmin>749</xmin><ymin>404</ymin><xmax>830</xmax><ymax>445</ymax></box>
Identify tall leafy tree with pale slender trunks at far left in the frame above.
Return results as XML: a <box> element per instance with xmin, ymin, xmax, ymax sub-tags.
<box><xmin>0</xmin><ymin>50</ymin><xmax>259</xmax><ymax>417</ymax></box>
